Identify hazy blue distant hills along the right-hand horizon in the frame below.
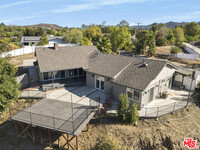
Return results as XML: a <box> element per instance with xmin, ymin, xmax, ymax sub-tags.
<box><xmin>131</xmin><ymin>21</ymin><xmax>200</xmax><ymax>29</ymax></box>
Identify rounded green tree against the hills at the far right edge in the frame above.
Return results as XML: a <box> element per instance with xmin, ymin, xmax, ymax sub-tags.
<box><xmin>185</xmin><ymin>22</ymin><xmax>200</xmax><ymax>37</ymax></box>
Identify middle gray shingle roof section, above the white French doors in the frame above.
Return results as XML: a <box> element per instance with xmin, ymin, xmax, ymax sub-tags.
<box><xmin>87</xmin><ymin>52</ymin><xmax>133</xmax><ymax>78</ymax></box>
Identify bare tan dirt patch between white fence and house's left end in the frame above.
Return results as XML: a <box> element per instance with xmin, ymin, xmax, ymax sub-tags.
<box><xmin>11</xmin><ymin>53</ymin><xmax>36</xmax><ymax>67</ymax></box>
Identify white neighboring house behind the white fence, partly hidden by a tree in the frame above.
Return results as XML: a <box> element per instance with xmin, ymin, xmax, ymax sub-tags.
<box><xmin>20</xmin><ymin>36</ymin><xmax>65</xmax><ymax>46</ymax></box>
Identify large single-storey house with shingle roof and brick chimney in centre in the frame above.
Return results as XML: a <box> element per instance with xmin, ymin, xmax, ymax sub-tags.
<box><xmin>36</xmin><ymin>44</ymin><xmax>188</xmax><ymax>107</ymax></box>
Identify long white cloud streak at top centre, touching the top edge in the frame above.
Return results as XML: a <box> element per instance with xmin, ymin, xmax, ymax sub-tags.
<box><xmin>52</xmin><ymin>0</ymin><xmax>161</xmax><ymax>13</ymax></box>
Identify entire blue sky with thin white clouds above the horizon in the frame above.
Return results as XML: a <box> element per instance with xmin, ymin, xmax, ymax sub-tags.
<box><xmin>0</xmin><ymin>0</ymin><xmax>200</xmax><ymax>27</ymax></box>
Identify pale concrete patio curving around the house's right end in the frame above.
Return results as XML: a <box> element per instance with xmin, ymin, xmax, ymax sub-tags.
<box><xmin>107</xmin><ymin>88</ymin><xmax>193</xmax><ymax>118</ymax></box>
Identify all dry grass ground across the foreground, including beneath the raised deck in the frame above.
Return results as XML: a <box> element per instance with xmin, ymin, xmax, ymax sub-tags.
<box><xmin>0</xmin><ymin>101</ymin><xmax>200</xmax><ymax>150</ymax></box>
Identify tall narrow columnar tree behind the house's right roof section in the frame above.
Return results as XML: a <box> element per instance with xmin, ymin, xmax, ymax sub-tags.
<box><xmin>148</xmin><ymin>31</ymin><xmax>156</xmax><ymax>56</ymax></box>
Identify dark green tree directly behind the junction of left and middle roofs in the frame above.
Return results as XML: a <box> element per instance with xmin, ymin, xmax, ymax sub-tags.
<box><xmin>97</xmin><ymin>35</ymin><xmax>112</xmax><ymax>53</ymax></box>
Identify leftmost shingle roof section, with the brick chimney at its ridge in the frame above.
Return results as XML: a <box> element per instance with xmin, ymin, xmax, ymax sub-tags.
<box><xmin>36</xmin><ymin>46</ymin><xmax>97</xmax><ymax>72</ymax></box>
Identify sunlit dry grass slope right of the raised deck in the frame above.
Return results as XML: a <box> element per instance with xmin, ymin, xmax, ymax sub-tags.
<box><xmin>77</xmin><ymin>106</ymin><xmax>200</xmax><ymax>150</ymax></box>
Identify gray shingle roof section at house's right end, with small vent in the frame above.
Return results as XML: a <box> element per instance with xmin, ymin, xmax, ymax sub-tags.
<box><xmin>113</xmin><ymin>58</ymin><xmax>168</xmax><ymax>91</ymax></box>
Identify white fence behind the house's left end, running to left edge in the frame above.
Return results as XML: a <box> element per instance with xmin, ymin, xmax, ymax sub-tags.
<box><xmin>1</xmin><ymin>44</ymin><xmax>79</xmax><ymax>58</ymax></box>
